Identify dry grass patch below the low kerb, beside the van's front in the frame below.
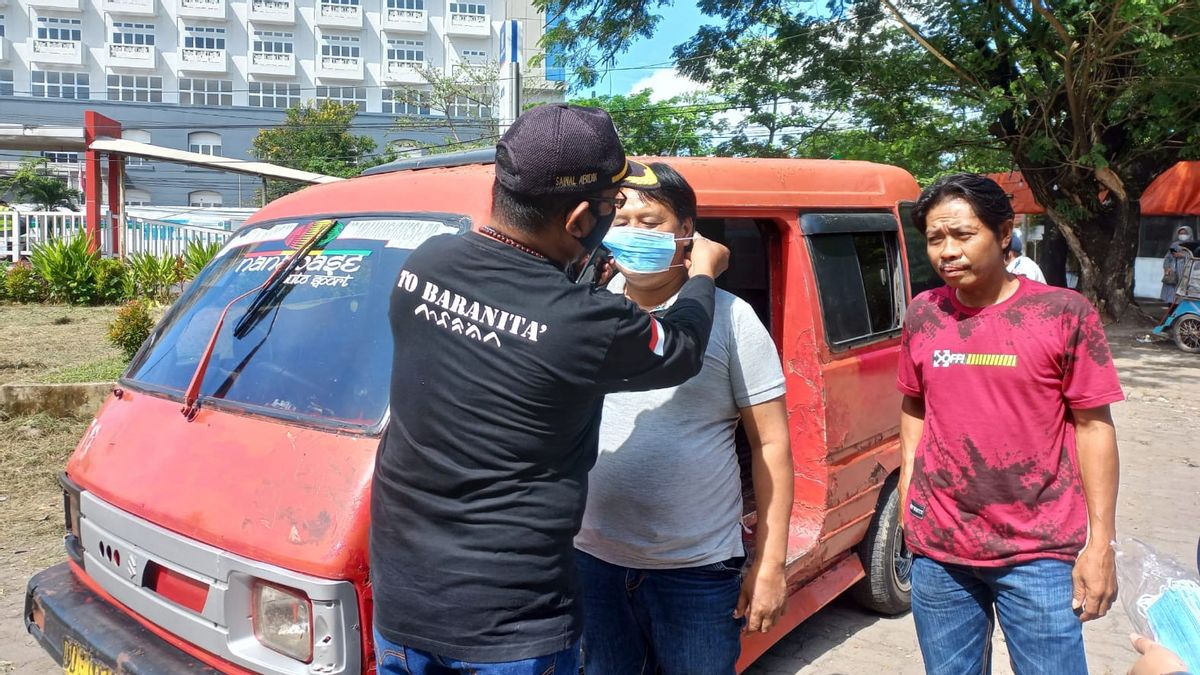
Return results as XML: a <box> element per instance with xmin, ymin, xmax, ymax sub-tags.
<box><xmin>0</xmin><ymin>414</ymin><xmax>89</xmax><ymax>573</ymax></box>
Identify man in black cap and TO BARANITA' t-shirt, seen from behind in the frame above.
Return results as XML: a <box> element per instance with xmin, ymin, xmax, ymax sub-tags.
<box><xmin>371</xmin><ymin>104</ymin><xmax>728</xmax><ymax>675</ymax></box>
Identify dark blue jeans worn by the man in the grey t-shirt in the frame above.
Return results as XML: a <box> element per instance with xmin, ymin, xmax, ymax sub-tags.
<box><xmin>575</xmin><ymin>550</ymin><xmax>744</xmax><ymax>675</ymax></box>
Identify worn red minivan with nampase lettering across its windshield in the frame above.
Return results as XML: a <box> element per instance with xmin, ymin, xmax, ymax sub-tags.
<box><xmin>25</xmin><ymin>153</ymin><xmax>932</xmax><ymax>675</ymax></box>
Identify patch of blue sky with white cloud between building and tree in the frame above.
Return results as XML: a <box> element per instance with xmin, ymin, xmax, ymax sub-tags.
<box><xmin>576</xmin><ymin>0</ymin><xmax>713</xmax><ymax>97</ymax></box>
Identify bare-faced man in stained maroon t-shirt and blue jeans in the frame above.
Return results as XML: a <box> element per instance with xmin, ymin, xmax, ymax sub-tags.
<box><xmin>898</xmin><ymin>174</ymin><xmax>1123</xmax><ymax>675</ymax></box>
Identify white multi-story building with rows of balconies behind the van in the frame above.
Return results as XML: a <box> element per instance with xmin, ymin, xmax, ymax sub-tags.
<box><xmin>0</xmin><ymin>0</ymin><xmax>564</xmax><ymax>207</ymax></box>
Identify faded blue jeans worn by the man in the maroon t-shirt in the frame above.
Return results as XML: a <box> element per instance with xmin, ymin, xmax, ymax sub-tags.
<box><xmin>912</xmin><ymin>557</ymin><xmax>1087</xmax><ymax>675</ymax></box>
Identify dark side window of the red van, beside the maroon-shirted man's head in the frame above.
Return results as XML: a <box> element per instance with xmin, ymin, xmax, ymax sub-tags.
<box><xmin>800</xmin><ymin>214</ymin><xmax>905</xmax><ymax>348</ymax></box>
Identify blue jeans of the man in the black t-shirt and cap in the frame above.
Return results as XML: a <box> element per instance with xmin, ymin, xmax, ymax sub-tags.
<box><xmin>374</xmin><ymin>631</ymin><xmax>580</xmax><ymax>675</ymax></box>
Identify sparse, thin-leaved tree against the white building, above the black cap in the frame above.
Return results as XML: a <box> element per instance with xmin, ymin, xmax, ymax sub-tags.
<box><xmin>392</xmin><ymin>64</ymin><xmax>499</xmax><ymax>154</ymax></box>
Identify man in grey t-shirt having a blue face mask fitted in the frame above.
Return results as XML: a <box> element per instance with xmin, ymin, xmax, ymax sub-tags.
<box><xmin>575</xmin><ymin>163</ymin><xmax>793</xmax><ymax>675</ymax></box>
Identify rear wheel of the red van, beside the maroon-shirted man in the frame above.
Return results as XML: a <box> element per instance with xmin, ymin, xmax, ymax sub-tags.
<box><xmin>850</xmin><ymin>473</ymin><xmax>912</xmax><ymax>615</ymax></box>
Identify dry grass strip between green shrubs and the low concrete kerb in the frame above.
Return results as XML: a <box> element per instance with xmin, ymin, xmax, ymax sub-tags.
<box><xmin>0</xmin><ymin>305</ymin><xmax>121</xmax><ymax>384</ymax></box>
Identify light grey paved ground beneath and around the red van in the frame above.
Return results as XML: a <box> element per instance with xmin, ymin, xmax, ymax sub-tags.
<box><xmin>0</xmin><ymin>321</ymin><xmax>1200</xmax><ymax>675</ymax></box>
